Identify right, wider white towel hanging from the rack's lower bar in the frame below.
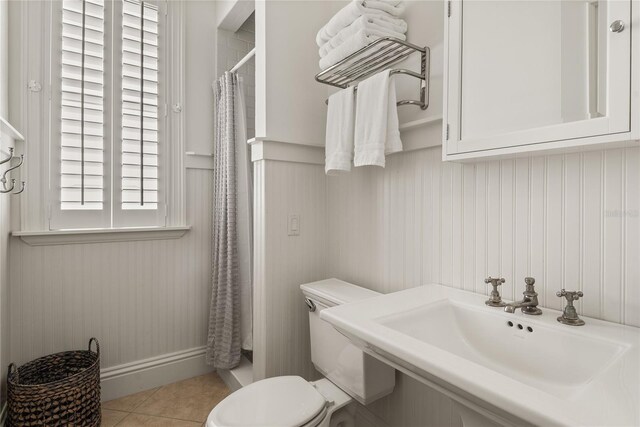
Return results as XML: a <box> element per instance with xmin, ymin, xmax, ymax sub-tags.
<box><xmin>353</xmin><ymin>70</ymin><xmax>402</xmax><ymax>167</ymax></box>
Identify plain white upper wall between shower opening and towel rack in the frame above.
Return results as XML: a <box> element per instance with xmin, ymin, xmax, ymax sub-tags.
<box><xmin>256</xmin><ymin>0</ymin><xmax>333</xmax><ymax>146</ymax></box>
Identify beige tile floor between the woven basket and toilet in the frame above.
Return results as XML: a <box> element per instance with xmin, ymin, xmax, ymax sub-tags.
<box><xmin>102</xmin><ymin>373</ymin><xmax>230</xmax><ymax>427</ymax></box>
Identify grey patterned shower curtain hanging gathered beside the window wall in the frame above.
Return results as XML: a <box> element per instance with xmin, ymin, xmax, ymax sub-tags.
<box><xmin>206</xmin><ymin>72</ymin><xmax>241</xmax><ymax>369</ymax></box>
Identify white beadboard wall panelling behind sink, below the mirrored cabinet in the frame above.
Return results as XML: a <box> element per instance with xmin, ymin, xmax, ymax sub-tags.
<box><xmin>327</xmin><ymin>147</ymin><xmax>640</xmax><ymax>326</ymax></box>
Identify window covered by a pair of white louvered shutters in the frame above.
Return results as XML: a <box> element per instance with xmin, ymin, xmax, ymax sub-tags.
<box><xmin>49</xmin><ymin>0</ymin><xmax>168</xmax><ymax>229</ymax></box>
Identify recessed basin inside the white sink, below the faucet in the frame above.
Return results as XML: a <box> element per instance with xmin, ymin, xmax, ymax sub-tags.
<box><xmin>377</xmin><ymin>299</ymin><xmax>627</xmax><ymax>397</ymax></box>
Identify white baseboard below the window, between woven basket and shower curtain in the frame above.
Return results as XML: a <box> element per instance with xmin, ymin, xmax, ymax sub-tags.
<box><xmin>100</xmin><ymin>347</ymin><xmax>214</xmax><ymax>402</ymax></box>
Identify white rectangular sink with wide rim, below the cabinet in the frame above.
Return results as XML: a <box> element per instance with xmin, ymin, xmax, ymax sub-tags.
<box><xmin>321</xmin><ymin>285</ymin><xmax>640</xmax><ymax>426</ymax></box>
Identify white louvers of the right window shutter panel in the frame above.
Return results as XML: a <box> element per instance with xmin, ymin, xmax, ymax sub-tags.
<box><xmin>121</xmin><ymin>0</ymin><xmax>159</xmax><ymax>210</ymax></box>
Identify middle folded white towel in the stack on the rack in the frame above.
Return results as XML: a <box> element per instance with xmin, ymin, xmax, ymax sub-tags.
<box><xmin>319</xmin><ymin>15</ymin><xmax>407</xmax><ymax>58</ymax></box>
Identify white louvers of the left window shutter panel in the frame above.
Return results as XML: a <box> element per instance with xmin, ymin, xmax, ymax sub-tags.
<box><xmin>60</xmin><ymin>0</ymin><xmax>105</xmax><ymax>210</ymax></box>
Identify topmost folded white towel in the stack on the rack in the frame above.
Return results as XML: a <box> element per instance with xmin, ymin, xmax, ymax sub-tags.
<box><xmin>316</xmin><ymin>0</ymin><xmax>404</xmax><ymax>47</ymax></box>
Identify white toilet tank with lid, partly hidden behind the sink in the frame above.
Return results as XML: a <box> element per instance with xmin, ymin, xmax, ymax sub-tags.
<box><xmin>300</xmin><ymin>279</ymin><xmax>395</xmax><ymax>405</ymax></box>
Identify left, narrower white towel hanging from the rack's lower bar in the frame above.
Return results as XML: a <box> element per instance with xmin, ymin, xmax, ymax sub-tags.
<box><xmin>324</xmin><ymin>86</ymin><xmax>355</xmax><ymax>175</ymax></box>
